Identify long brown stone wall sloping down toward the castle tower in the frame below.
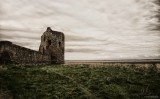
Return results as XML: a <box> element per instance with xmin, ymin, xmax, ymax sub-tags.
<box><xmin>0</xmin><ymin>41</ymin><xmax>51</xmax><ymax>64</ymax></box>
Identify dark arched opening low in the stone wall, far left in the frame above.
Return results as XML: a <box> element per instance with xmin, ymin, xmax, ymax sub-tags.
<box><xmin>0</xmin><ymin>51</ymin><xmax>11</xmax><ymax>64</ymax></box>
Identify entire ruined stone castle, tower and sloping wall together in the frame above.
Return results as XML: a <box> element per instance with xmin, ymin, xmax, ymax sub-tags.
<box><xmin>0</xmin><ymin>27</ymin><xmax>65</xmax><ymax>64</ymax></box>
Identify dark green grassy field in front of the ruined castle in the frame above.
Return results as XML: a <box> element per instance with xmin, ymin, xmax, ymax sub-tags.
<box><xmin>0</xmin><ymin>65</ymin><xmax>160</xmax><ymax>99</ymax></box>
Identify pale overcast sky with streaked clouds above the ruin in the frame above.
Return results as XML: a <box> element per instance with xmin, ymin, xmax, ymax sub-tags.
<box><xmin>0</xmin><ymin>0</ymin><xmax>160</xmax><ymax>60</ymax></box>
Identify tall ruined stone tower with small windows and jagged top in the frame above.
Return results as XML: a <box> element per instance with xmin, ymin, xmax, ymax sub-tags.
<box><xmin>39</xmin><ymin>27</ymin><xmax>64</xmax><ymax>64</ymax></box>
